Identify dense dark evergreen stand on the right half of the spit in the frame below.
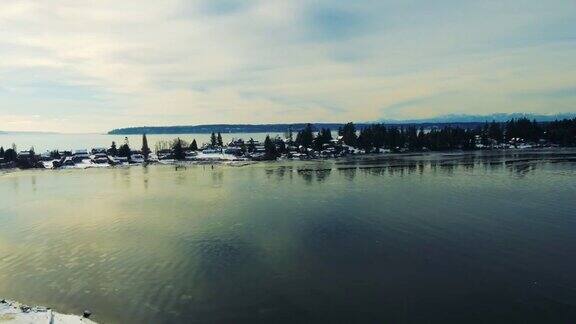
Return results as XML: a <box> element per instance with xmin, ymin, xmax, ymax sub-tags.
<box><xmin>295</xmin><ymin>118</ymin><xmax>576</xmax><ymax>152</ymax></box>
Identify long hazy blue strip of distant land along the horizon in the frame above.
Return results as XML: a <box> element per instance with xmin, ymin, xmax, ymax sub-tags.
<box><xmin>107</xmin><ymin>113</ymin><xmax>576</xmax><ymax>135</ymax></box>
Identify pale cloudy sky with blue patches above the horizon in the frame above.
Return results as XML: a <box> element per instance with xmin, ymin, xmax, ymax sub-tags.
<box><xmin>0</xmin><ymin>0</ymin><xmax>576</xmax><ymax>133</ymax></box>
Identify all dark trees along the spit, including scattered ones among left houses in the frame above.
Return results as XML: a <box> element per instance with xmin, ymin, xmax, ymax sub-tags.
<box><xmin>0</xmin><ymin>118</ymin><xmax>576</xmax><ymax>162</ymax></box>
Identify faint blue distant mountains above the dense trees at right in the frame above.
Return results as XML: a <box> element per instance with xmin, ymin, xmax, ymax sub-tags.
<box><xmin>379</xmin><ymin>113</ymin><xmax>576</xmax><ymax>124</ymax></box>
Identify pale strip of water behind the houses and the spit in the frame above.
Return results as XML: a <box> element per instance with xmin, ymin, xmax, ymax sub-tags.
<box><xmin>0</xmin><ymin>133</ymin><xmax>283</xmax><ymax>153</ymax></box>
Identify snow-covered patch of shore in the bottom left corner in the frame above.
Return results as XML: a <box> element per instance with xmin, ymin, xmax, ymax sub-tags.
<box><xmin>0</xmin><ymin>300</ymin><xmax>96</xmax><ymax>324</ymax></box>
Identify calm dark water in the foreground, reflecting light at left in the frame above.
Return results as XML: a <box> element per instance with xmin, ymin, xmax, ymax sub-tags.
<box><xmin>0</xmin><ymin>152</ymin><xmax>576</xmax><ymax>323</ymax></box>
